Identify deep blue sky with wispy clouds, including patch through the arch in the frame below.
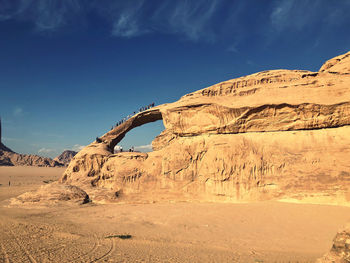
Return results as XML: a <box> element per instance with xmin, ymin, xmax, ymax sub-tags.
<box><xmin>0</xmin><ymin>0</ymin><xmax>350</xmax><ymax>157</ymax></box>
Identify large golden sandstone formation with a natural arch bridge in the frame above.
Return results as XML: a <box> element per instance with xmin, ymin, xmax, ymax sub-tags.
<box><xmin>60</xmin><ymin>53</ymin><xmax>350</xmax><ymax>204</ymax></box>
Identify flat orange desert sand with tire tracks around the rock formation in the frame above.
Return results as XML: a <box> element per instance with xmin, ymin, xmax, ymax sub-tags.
<box><xmin>0</xmin><ymin>167</ymin><xmax>350</xmax><ymax>263</ymax></box>
